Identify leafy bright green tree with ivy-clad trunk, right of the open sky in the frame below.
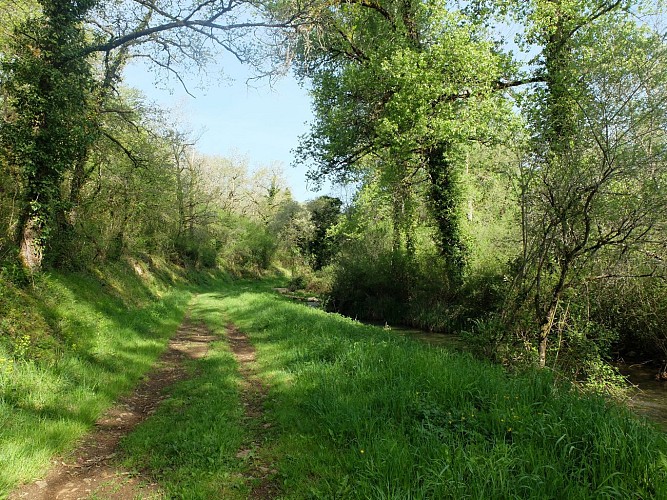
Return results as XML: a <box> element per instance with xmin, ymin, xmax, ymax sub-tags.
<box><xmin>299</xmin><ymin>1</ymin><xmax>519</xmax><ymax>277</ymax></box>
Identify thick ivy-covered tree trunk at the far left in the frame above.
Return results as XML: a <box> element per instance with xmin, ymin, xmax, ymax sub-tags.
<box><xmin>0</xmin><ymin>0</ymin><xmax>96</xmax><ymax>271</ymax></box>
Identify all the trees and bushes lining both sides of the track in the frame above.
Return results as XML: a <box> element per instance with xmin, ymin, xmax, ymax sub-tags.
<box><xmin>0</xmin><ymin>0</ymin><xmax>667</xmax><ymax>410</ymax></box>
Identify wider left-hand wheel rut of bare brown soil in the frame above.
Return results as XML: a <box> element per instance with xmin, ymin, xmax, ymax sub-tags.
<box><xmin>9</xmin><ymin>317</ymin><xmax>218</xmax><ymax>500</ymax></box>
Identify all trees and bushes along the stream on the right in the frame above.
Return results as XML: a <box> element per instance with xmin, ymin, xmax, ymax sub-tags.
<box><xmin>290</xmin><ymin>0</ymin><xmax>667</xmax><ymax>382</ymax></box>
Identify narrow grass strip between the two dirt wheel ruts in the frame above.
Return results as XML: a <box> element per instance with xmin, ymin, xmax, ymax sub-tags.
<box><xmin>122</xmin><ymin>293</ymin><xmax>250</xmax><ymax>498</ymax></box>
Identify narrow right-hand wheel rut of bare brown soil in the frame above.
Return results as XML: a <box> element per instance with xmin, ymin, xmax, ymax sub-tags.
<box><xmin>227</xmin><ymin>324</ymin><xmax>280</xmax><ymax>500</ymax></box>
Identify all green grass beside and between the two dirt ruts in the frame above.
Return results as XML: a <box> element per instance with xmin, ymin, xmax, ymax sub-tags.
<box><xmin>5</xmin><ymin>273</ymin><xmax>667</xmax><ymax>499</ymax></box>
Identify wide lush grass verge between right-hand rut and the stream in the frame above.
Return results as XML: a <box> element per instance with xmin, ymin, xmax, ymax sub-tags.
<box><xmin>211</xmin><ymin>284</ymin><xmax>667</xmax><ymax>499</ymax></box>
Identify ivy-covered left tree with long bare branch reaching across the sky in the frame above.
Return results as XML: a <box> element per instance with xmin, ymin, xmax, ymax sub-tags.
<box><xmin>0</xmin><ymin>0</ymin><xmax>308</xmax><ymax>270</ymax></box>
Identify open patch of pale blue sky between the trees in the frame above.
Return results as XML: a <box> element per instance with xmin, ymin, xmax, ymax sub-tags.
<box><xmin>125</xmin><ymin>58</ymin><xmax>326</xmax><ymax>201</ymax></box>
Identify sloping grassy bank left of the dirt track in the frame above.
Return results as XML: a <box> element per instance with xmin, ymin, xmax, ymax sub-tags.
<box><xmin>0</xmin><ymin>264</ymin><xmax>190</xmax><ymax>497</ymax></box>
